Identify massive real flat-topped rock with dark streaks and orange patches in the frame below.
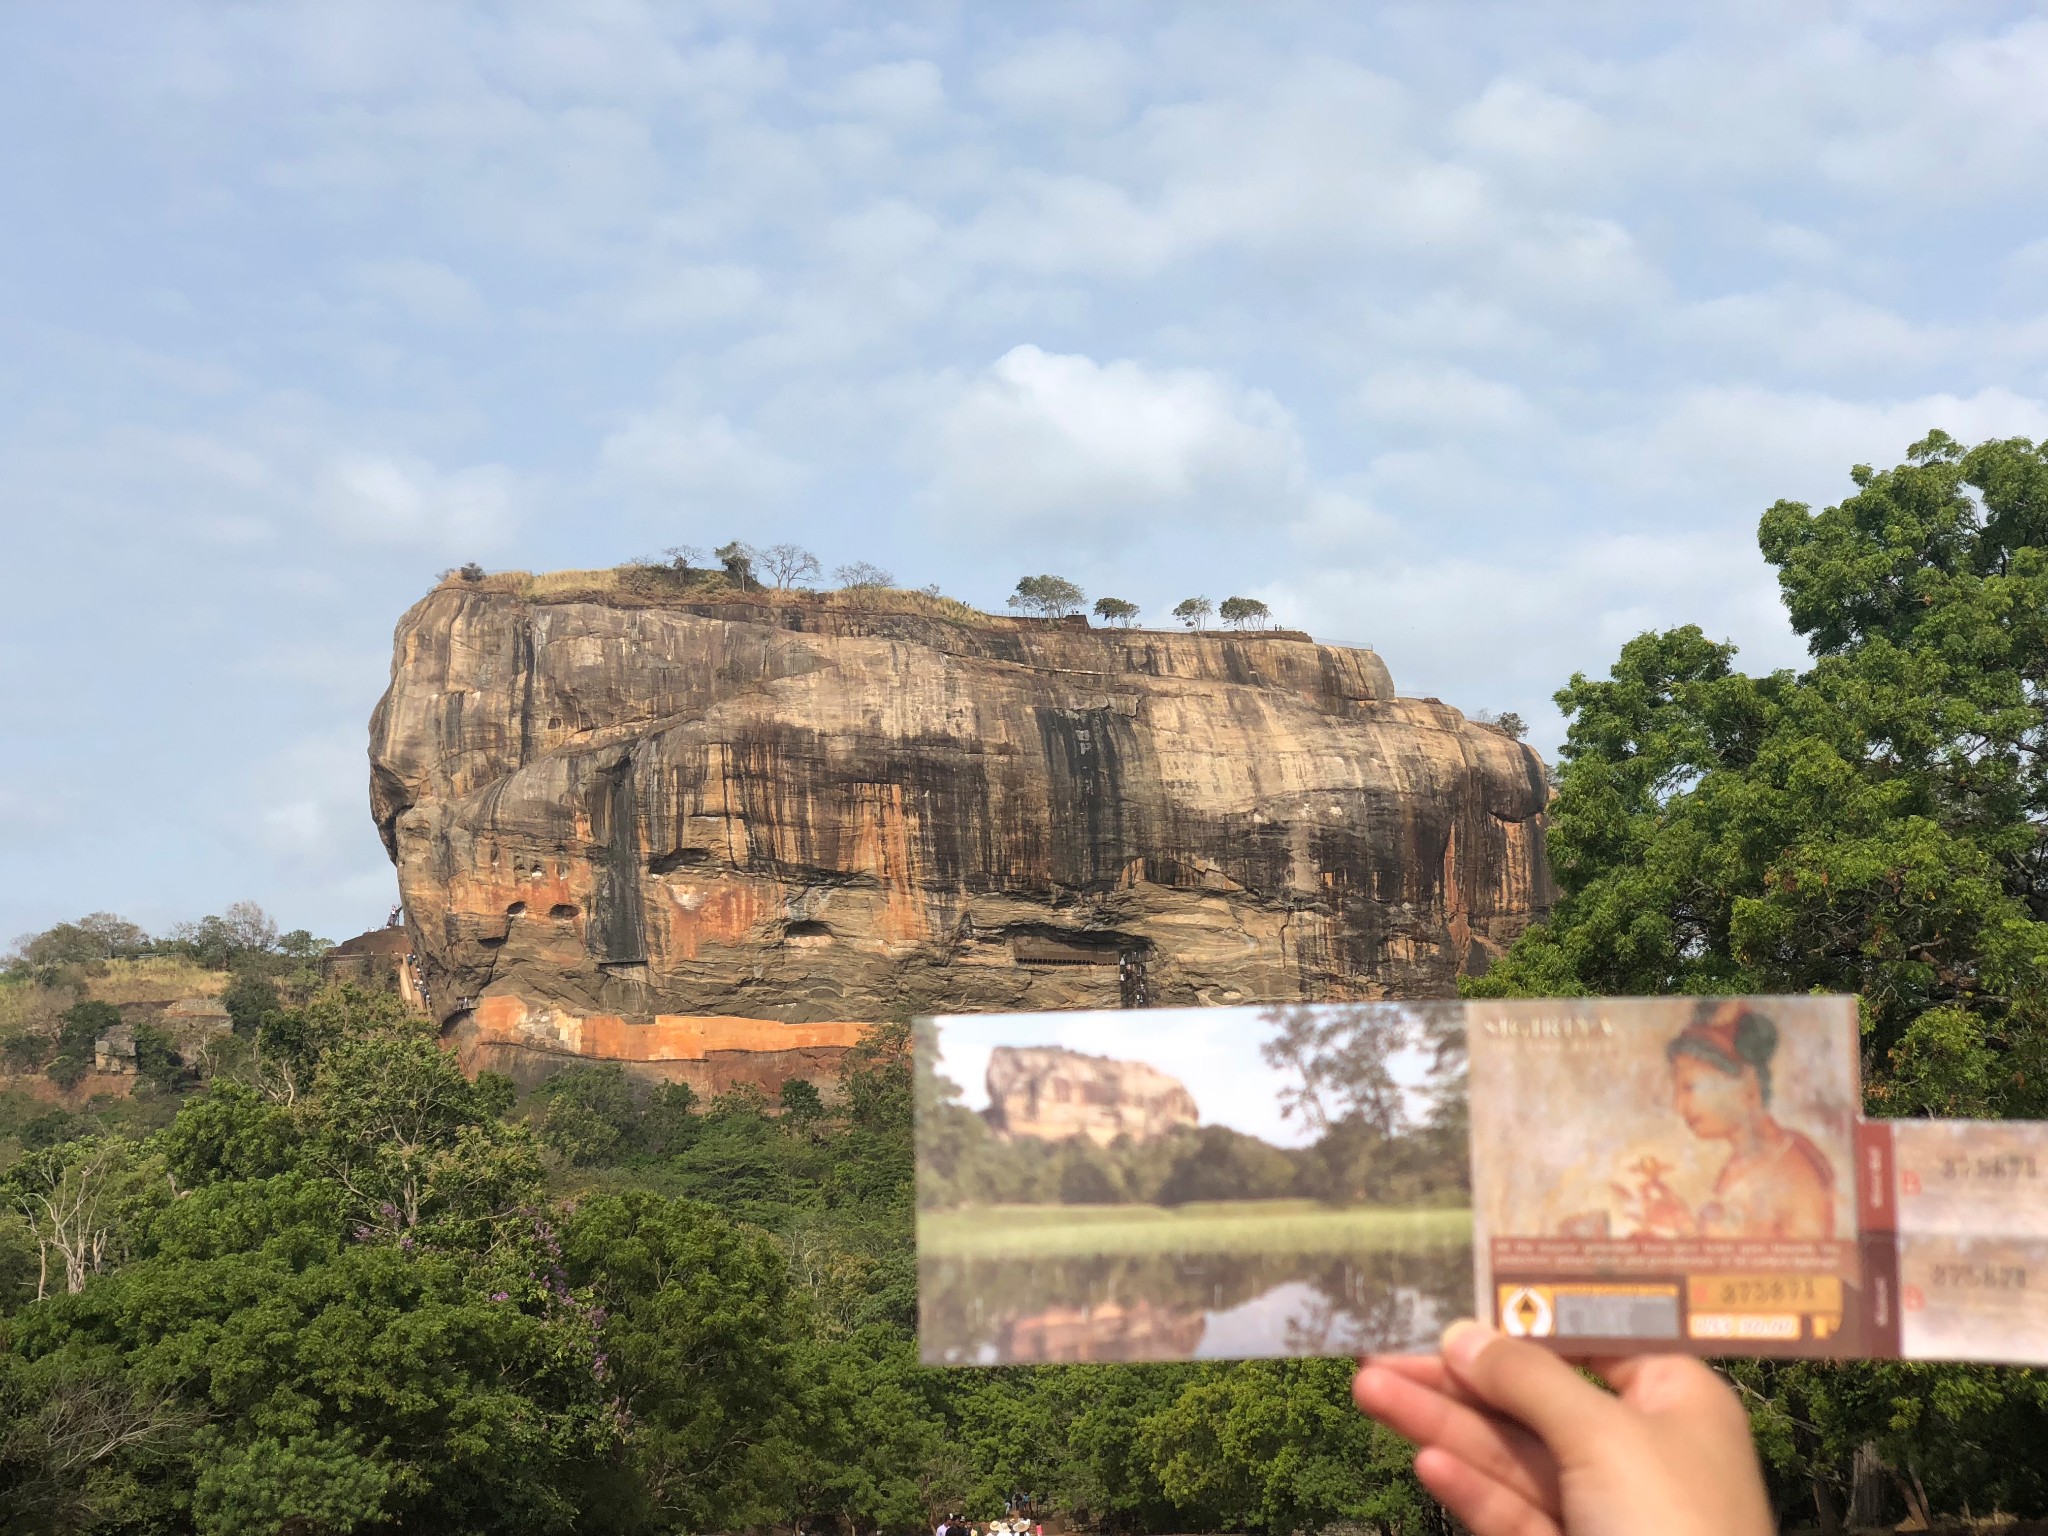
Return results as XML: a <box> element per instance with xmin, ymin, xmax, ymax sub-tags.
<box><xmin>371</xmin><ymin>573</ymin><xmax>1548</xmax><ymax>1083</ymax></box>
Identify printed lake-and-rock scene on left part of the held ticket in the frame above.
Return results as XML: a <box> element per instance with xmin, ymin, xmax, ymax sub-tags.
<box><xmin>918</xmin><ymin>1004</ymin><xmax>1473</xmax><ymax>1364</ymax></box>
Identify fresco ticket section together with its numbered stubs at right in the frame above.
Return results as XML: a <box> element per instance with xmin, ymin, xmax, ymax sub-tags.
<box><xmin>1466</xmin><ymin>997</ymin><xmax>2048</xmax><ymax>1364</ymax></box>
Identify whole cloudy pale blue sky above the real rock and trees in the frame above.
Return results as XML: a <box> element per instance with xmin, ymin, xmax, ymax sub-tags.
<box><xmin>0</xmin><ymin>0</ymin><xmax>2048</xmax><ymax>938</ymax></box>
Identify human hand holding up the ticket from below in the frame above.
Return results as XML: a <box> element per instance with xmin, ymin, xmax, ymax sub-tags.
<box><xmin>1352</xmin><ymin>1319</ymin><xmax>1776</xmax><ymax>1536</ymax></box>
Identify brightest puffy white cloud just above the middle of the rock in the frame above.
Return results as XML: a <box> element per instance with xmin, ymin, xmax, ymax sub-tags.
<box><xmin>920</xmin><ymin>344</ymin><xmax>1305</xmax><ymax>541</ymax></box>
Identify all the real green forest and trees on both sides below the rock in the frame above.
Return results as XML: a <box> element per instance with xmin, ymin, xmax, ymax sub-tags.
<box><xmin>0</xmin><ymin>434</ymin><xmax>2048</xmax><ymax>1536</ymax></box>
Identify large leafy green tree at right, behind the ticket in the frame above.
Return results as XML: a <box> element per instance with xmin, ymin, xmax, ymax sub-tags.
<box><xmin>1466</xmin><ymin>432</ymin><xmax>2048</xmax><ymax>1511</ymax></box>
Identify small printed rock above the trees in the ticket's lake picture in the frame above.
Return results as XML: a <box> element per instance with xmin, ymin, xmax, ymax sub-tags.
<box><xmin>983</xmin><ymin>1044</ymin><xmax>1200</xmax><ymax>1147</ymax></box>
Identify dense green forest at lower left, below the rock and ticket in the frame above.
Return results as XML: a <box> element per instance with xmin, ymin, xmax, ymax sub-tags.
<box><xmin>0</xmin><ymin>987</ymin><xmax>1434</xmax><ymax>1536</ymax></box>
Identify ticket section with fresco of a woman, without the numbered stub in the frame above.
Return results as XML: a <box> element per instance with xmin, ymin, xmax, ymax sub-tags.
<box><xmin>1468</xmin><ymin>997</ymin><xmax>1868</xmax><ymax>1356</ymax></box>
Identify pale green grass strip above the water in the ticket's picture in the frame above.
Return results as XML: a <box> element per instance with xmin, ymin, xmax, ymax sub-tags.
<box><xmin>918</xmin><ymin>1200</ymin><xmax>1473</xmax><ymax>1257</ymax></box>
